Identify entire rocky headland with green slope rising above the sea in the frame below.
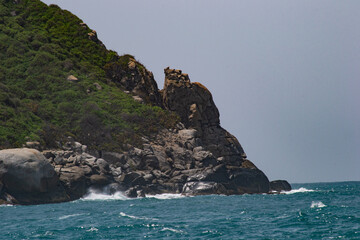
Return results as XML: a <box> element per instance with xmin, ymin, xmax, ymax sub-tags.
<box><xmin>0</xmin><ymin>0</ymin><xmax>289</xmax><ymax>204</ymax></box>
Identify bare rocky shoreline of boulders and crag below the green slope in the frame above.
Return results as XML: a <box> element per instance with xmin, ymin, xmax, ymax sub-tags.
<box><xmin>0</xmin><ymin>68</ymin><xmax>291</xmax><ymax>204</ymax></box>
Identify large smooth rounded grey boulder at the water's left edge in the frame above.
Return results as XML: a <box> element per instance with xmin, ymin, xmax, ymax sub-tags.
<box><xmin>0</xmin><ymin>148</ymin><xmax>70</xmax><ymax>204</ymax></box>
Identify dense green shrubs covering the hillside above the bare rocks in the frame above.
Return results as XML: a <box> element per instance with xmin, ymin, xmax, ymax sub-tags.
<box><xmin>0</xmin><ymin>0</ymin><xmax>178</xmax><ymax>151</ymax></box>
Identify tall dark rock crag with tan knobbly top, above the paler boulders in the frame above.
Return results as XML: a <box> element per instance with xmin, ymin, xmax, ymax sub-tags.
<box><xmin>161</xmin><ymin>68</ymin><xmax>246</xmax><ymax>162</ymax></box>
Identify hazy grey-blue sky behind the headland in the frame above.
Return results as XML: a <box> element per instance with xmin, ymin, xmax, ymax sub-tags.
<box><xmin>40</xmin><ymin>0</ymin><xmax>360</xmax><ymax>183</ymax></box>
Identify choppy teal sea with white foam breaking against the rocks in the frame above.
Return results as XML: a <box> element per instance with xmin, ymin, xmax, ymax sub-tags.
<box><xmin>0</xmin><ymin>182</ymin><xmax>360</xmax><ymax>239</ymax></box>
